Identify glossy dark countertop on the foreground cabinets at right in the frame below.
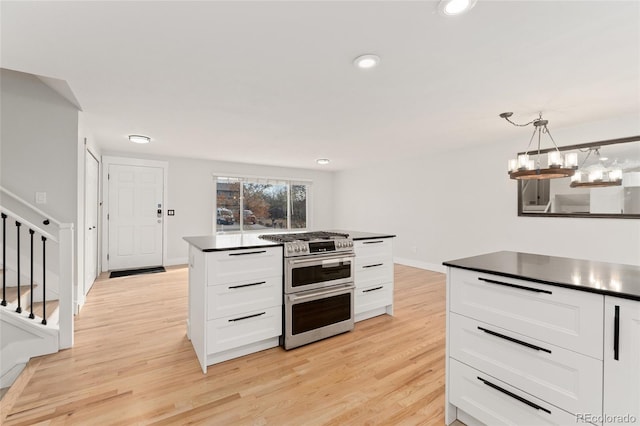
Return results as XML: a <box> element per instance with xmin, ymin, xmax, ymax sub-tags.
<box><xmin>443</xmin><ymin>251</ymin><xmax>640</xmax><ymax>301</ymax></box>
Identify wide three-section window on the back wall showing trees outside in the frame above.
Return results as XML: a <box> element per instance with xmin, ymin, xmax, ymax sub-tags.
<box><xmin>215</xmin><ymin>176</ymin><xmax>311</xmax><ymax>232</ymax></box>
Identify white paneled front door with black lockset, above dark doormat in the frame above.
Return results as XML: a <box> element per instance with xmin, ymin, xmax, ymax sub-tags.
<box><xmin>107</xmin><ymin>164</ymin><xmax>164</xmax><ymax>270</ymax></box>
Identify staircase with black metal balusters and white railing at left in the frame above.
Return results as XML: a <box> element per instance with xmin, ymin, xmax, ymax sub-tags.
<box><xmin>0</xmin><ymin>188</ymin><xmax>73</xmax><ymax>395</ymax></box>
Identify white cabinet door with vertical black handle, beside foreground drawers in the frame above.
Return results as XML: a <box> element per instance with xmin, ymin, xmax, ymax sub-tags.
<box><xmin>604</xmin><ymin>296</ymin><xmax>640</xmax><ymax>425</ymax></box>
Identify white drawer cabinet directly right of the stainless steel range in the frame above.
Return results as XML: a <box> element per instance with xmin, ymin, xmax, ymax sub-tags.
<box><xmin>354</xmin><ymin>238</ymin><xmax>394</xmax><ymax>322</ymax></box>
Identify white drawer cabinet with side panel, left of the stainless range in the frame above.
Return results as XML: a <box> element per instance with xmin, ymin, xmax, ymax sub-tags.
<box><xmin>187</xmin><ymin>245</ymin><xmax>283</xmax><ymax>373</ymax></box>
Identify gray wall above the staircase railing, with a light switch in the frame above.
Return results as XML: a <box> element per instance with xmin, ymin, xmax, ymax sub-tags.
<box><xmin>0</xmin><ymin>69</ymin><xmax>78</xmax><ymax>223</ymax></box>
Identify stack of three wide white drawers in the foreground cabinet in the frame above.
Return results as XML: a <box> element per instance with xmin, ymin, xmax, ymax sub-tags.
<box><xmin>446</xmin><ymin>267</ymin><xmax>604</xmax><ymax>425</ymax></box>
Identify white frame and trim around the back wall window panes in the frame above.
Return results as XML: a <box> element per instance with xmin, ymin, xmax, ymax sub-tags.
<box><xmin>212</xmin><ymin>173</ymin><xmax>313</xmax><ymax>235</ymax></box>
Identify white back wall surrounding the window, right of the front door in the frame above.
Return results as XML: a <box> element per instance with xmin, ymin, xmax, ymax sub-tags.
<box><xmin>103</xmin><ymin>152</ymin><xmax>334</xmax><ymax>265</ymax></box>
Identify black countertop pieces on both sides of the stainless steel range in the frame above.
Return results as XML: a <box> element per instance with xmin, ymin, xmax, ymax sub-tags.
<box><xmin>183</xmin><ymin>230</ymin><xmax>395</xmax><ymax>252</ymax></box>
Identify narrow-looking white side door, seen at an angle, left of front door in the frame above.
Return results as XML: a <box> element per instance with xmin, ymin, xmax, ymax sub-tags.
<box><xmin>84</xmin><ymin>151</ymin><xmax>100</xmax><ymax>295</ymax></box>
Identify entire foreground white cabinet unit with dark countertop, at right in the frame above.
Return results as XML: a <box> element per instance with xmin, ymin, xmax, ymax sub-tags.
<box><xmin>444</xmin><ymin>251</ymin><xmax>640</xmax><ymax>425</ymax></box>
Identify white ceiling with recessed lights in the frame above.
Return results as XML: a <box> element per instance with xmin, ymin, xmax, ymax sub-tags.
<box><xmin>0</xmin><ymin>0</ymin><xmax>640</xmax><ymax>170</ymax></box>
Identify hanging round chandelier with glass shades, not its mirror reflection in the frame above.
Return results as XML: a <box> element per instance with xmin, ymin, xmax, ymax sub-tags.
<box><xmin>500</xmin><ymin>112</ymin><xmax>578</xmax><ymax>180</ymax></box>
